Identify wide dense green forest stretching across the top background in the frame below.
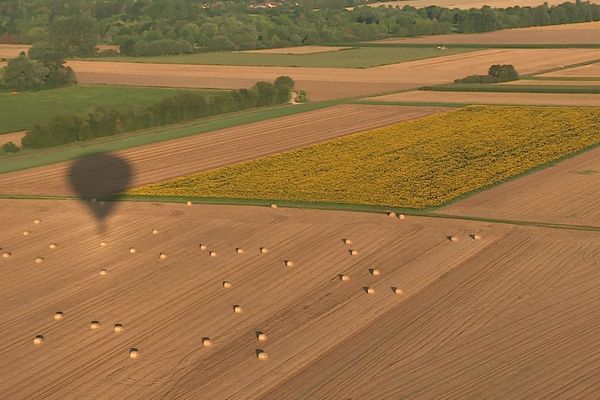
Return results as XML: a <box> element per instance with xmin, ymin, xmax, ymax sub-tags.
<box><xmin>0</xmin><ymin>0</ymin><xmax>600</xmax><ymax>56</ymax></box>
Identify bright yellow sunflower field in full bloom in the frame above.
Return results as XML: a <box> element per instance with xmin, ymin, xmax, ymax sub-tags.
<box><xmin>129</xmin><ymin>106</ymin><xmax>600</xmax><ymax>208</ymax></box>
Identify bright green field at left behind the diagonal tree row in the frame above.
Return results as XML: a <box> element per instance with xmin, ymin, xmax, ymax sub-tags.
<box><xmin>0</xmin><ymin>85</ymin><xmax>224</xmax><ymax>133</ymax></box>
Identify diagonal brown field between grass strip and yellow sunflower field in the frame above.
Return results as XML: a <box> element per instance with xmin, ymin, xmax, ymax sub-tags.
<box><xmin>0</xmin><ymin>105</ymin><xmax>445</xmax><ymax>195</ymax></box>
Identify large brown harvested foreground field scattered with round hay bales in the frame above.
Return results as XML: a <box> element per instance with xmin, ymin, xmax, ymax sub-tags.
<box><xmin>0</xmin><ymin>200</ymin><xmax>600</xmax><ymax>400</ymax></box>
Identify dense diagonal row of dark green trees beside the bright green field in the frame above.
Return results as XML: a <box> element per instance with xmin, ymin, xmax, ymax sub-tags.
<box><xmin>22</xmin><ymin>76</ymin><xmax>294</xmax><ymax>148</ymax></box>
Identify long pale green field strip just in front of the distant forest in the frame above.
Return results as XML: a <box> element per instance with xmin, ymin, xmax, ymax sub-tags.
<box><xmin>84</xmin><ymin>46</ymin><xmax>474</xmax><ymax>68</ymax></box>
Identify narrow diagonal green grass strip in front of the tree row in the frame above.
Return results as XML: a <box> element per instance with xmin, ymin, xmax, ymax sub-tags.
<box><xmin>0</xmin><ymin>100</ymin><xmax>343</xmax><ymax>173</ymax></box>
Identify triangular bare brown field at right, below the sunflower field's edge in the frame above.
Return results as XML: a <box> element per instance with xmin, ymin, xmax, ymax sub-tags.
<box><xmin>440</xmin><ymin>148</ymin><xmax>600</xmax><ymax>227</ymax></box>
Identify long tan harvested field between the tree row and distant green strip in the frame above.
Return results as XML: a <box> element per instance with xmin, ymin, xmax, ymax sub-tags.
<box><xmin>68</xmin><ymin>49</ymin><xmax>600</xmax><ymax>100</ymax></box>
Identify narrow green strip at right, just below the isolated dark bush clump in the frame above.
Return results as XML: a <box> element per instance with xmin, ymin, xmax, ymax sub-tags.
<box><xmin>421</xmin><ymin>83</ymin><xmax>600</xmax><ymax>94</ymax></box>
